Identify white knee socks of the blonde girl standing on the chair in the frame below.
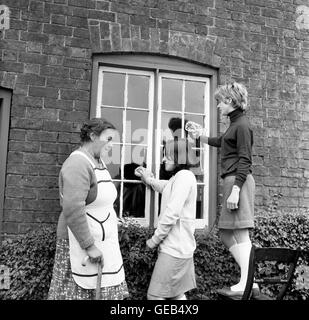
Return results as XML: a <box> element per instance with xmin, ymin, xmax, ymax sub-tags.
<box><xmin>229</xmin><ymin>241</ymin><xmax>252</xmax><ymax>291</ymax></box>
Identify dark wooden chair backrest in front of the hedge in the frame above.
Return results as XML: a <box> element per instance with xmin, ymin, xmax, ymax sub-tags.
<box><xmin>242</xmin><ymin>245</ymin><xmax>301</xmax><ymax>300</ymax></box>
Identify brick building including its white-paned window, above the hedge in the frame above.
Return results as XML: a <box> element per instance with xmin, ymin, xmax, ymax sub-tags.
<box><xmin>0</xmin><ymin>0</ymin><xmax>309</xmax><ymax>235</ymax></box>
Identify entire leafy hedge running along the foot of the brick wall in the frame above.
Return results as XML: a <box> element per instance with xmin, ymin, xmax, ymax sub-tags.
<box><xmin>0</xmin><ymin>214</ymin><xmax>309</xmax><ymax>300</ymax></box>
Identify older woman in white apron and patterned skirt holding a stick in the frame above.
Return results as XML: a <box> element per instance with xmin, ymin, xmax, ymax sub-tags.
<box><xmin>48</xmin><ymin>118</ymin><xmax>128</xmax><ymax>300</ymax></box>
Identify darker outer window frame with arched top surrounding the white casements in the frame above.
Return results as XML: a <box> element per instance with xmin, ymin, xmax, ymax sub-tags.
<box><xmin>90</xmin><ymin>52</ymin><xmax>219</xmax><ymax>228</ymax></box>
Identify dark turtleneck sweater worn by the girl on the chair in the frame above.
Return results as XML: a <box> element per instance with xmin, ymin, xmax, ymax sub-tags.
<box><xmin>208</xmin><ymin>109</ymin><xmax>253</xmax><ymax>188</ymax></box>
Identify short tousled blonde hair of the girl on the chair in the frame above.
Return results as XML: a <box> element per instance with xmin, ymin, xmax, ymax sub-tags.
<box><xmin>215</xmin><ymin>82</ymin><xmax>248</xmax><ymax>111</ymax></box>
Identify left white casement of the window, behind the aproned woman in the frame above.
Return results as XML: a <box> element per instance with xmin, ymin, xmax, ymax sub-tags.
<box><xmin>96</xmin><ymin>66</ymin><xmax>154</xmax><ymax>224</ymax></box>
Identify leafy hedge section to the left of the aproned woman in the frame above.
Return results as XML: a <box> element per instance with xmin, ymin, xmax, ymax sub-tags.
<box><xmin>0</xmin><ymin>226</ymin><xmax>56</xmax><ymax>300</ymax></box>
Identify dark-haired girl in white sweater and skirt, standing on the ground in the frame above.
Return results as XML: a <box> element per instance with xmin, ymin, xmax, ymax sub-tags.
<box><xmin>135</xmin><ymin>138</ymin><xmax>197</xmax><ymax>300</ymax></box>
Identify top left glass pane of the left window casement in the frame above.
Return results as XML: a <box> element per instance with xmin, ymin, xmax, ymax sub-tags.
<box><xmin>102</xmin><ymin>72</ymin><xmax>125</xmax><ymax>107</ymax></box>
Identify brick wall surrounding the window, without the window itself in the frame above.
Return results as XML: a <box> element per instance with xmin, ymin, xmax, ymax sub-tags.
<box><xmin>0</xmin><ymin>0</ymin><xmax>309</xmax><ymax>233</ymax></box>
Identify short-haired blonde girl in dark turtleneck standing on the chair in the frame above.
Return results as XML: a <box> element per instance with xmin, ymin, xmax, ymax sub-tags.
<box><xmin>191</xmin><ymin>82</ymin><xmax>259</xmax><ymax>296</ymax></box>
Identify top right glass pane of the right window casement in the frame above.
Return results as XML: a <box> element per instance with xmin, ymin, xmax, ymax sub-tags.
<box><xmin>185</xmin><ymin>81</ymin><xmax>205</xmax><ymax>113</ymax></box>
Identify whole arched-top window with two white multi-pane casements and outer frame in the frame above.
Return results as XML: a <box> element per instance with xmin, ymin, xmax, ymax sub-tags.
<box><xmin>91</xmin><ymin>55</ymin><xmax>217</xmax><ymax>228</ymax></box>
